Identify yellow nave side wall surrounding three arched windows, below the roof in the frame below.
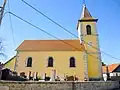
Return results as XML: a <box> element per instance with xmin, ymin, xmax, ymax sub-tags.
<box><xmin>16</xmin><ymin>51</ymin><xmax>84</xmax><ymax>80</ymax></box>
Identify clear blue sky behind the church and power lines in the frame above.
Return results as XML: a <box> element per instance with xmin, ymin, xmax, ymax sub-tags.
<box><xmin>0</xmin><ymin>0</ymin><xmax>120</xmax><ymax>64</ymax></box>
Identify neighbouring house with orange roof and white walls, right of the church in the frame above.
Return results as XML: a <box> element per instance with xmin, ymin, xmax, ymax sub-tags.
<box><xmin>102</xmin><ymin>64</ymin><xmax>120</xmax><ymax>80</ymax></box>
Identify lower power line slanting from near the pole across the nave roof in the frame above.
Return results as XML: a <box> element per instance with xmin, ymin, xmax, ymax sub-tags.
<box><xmin>9</xmin><ymin>12</ymin><xmax>98</xmax><ymax>59</ymax></box>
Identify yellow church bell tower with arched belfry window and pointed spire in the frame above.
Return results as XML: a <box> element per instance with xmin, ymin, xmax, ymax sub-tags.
<box><xmin>77</xmin><ymin>5</ymin><xmax>102</xmax><ymax>80</ymax></box>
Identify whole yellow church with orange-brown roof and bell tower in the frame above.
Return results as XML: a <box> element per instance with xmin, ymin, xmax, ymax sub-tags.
<box><xmin>5</xmin><ymin>5</ymin><xmax>102</xmax><ymax>81</ymax></box>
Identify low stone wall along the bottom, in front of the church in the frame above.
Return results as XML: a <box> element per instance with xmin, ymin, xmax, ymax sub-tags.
<box><xmin>0</xmin><ymin>81</ymin><xmax>119</xmax><ymax>90</ymax></box>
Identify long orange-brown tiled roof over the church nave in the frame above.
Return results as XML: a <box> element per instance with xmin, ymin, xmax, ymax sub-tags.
<box><xmin>17</xmin><ymin>40</ymin><xmax>85</xmax><ymax>51</ymax></box>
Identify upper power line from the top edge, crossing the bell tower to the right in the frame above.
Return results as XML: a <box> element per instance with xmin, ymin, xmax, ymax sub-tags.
<box><xmin>22</xmin><ymin>0</ymin><xmax>120</xmax><ymax>60</ymax></box>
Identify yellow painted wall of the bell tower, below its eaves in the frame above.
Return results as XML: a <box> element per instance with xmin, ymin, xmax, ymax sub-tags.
<box><xmin>79</xmin><ymin>19</ymin><xmax>102</xmax><ymax>78</ymax></box>
